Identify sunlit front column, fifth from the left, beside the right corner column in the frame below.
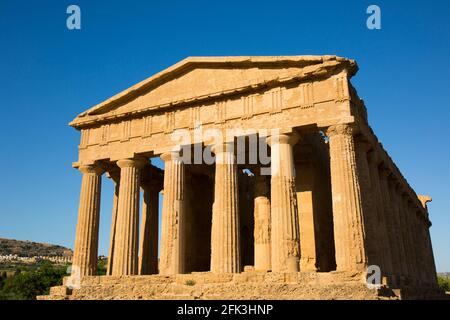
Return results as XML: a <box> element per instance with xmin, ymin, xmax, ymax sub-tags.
<box><xmin>267</xmin><ymin>134</ymin><xmax>300</xmax><ymax>272</ymax></box>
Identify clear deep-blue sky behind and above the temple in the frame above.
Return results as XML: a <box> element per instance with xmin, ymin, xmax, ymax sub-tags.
<box><xmin>0</xmin><ymin>0</ymin><xmax>450</xmax><ymax>271</ymax></box>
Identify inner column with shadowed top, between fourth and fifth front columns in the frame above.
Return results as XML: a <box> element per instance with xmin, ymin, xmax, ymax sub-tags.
<box><xmin>254</xmin><ymin>175</ymin><xmax>272</xmax><ymax>271</ymax></box>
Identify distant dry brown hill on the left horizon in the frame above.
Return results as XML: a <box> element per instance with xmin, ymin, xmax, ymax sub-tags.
<box><xmin>0</xmin><ymin>238</ymin><xmax>72</xmax><ymax>257</ymax></box>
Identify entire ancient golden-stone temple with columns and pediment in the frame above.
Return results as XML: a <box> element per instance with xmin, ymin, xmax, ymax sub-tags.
<box><xmin>41</xmin><ymin>56</ymin><xmax>442</xmax><ymax>299</ymax></box>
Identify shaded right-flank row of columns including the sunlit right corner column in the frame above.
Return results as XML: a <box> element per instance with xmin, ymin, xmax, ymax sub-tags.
<box><xmin>338</xmin><ymin>125</ymin><xmax>436</xmax><ymax>286</ymax></box>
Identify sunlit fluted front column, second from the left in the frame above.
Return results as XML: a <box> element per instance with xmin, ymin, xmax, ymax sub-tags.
<box><xmin>112</xmin><ymin>158</ymin><xmax>146</xmax><ymax>276</ymax></box>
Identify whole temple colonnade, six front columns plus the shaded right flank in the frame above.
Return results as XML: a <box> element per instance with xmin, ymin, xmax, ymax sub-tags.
<box><xmin>73</xmin><ymin>124</ymin><xmax>434</xmax><ymax>288</ymax></box>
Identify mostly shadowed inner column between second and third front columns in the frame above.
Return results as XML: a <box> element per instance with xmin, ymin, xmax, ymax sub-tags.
<box><xmin>139</xmin><ymin>185</ymin><xmax>159</xmax><ymax>275</ymax></box>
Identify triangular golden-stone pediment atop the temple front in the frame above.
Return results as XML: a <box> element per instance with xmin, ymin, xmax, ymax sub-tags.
<box><xmin>71</xmin><ymin>56</ymin><xmax>357</xmax><ymax>127</ymax></box>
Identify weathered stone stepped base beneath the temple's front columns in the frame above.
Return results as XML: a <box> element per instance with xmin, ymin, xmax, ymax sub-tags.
<box><xmin>38</xmin><ymin>272</ymin><xmax>399</xmax><ymax>300</ymax></box>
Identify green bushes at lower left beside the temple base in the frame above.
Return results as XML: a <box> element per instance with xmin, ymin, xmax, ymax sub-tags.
<box><xmin>0</xmin><ymin>261</ymin><xmax>67</xmax><ymax>300</ymax></box>
